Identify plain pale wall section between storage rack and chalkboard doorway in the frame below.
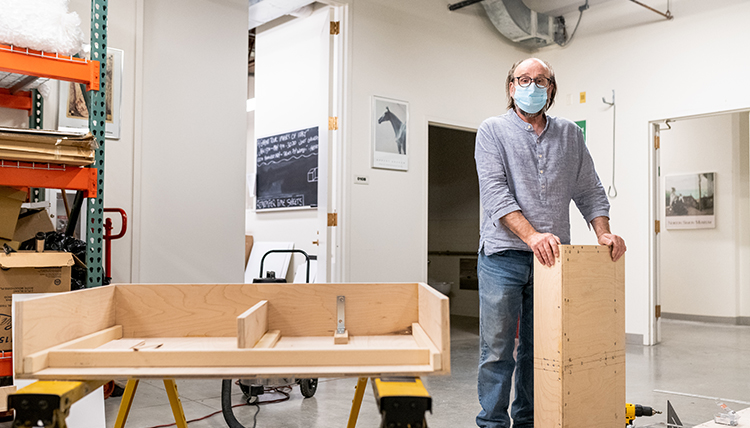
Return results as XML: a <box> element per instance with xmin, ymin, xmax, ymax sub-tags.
<box><xmin>136</xmin><ymin>0</ymin><xmax>248</xmax><ymax>282</ymax></box>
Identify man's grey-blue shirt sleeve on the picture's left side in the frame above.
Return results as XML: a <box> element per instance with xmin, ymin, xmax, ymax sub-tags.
<box><xmin>474</xmin><ymin>122</ymin><xmax>521</xmax><ymax>227</ymax></box>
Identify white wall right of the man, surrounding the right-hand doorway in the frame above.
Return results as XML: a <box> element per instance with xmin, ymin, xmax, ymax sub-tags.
<box><xmin>538</xmin><ymin>0</ymin><xmax>750</xmax><ymax>340</ymax></box>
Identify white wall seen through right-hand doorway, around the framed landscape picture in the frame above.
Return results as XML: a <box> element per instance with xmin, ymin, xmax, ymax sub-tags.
<box><xmin>659</xmin><ymin>113</ymin><xmax>749</xmax><ymax>321</ymax></box>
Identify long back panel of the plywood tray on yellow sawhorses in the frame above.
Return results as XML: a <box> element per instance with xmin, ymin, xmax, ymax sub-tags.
<box><xmin>116</xmin><ymin>284</ymin><xmax>418</xmax><ymax>337</ymax></box>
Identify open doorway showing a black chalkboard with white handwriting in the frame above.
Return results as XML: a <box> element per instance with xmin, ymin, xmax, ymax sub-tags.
<box><xmin>250</xmin><ymin>2</ymin><xmax>347</xmax><ymax>282</ymax></box>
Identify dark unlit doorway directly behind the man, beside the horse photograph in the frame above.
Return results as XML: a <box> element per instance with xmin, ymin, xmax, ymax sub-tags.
<box><xmin>427</xmin><ymin>123</ymin><xmax>480</xmax><ymax>317</ymax></box>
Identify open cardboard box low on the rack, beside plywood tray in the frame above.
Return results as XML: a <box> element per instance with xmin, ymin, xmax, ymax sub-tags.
<box><xmin>0</xmin><ymin>251</ymin><xmax>73</xmax><ymax>351</ymax></box>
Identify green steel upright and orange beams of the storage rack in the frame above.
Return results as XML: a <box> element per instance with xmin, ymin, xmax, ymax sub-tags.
<box><xmin>0</xmin><ymin>0</ymin><xmax>108</xmax><ymax>287</ymax></box>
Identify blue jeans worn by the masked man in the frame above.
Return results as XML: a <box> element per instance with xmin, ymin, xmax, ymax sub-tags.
<box><xmin>476</xmin><ymin>250</ymin><xmax>534</xmax><ymax>428</ymax></box>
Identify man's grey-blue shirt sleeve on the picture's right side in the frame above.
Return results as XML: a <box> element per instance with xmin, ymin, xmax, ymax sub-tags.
<box><xmin>573</xmin><ymin>141</ymin><xmax>609</xmax><ymax>223</ymax></box>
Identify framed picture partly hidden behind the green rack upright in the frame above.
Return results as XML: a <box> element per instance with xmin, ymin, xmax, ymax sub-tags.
<box><xmin>57</xmin><ymin>48</ymin><xmax>124</xmax><ymax>139</ymax></box>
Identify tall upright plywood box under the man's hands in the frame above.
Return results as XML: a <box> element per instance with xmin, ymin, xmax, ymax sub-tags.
<box><xmin>534</xmin><ymin>245</ymin><xmax>625</xmax><ymax>428</ymax></box>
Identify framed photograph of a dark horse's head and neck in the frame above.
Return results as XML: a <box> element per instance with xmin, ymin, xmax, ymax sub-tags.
<box><xmin>372</xmin><ymin>96</ymin><xmax>409</xmax><ymax>171</ymax></box>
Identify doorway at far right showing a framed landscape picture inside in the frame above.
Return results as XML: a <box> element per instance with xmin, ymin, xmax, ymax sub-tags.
<box><xmin>649</xmin><ymin>111</ymin><xmax>750</xmax><ymax>344</ymax></box>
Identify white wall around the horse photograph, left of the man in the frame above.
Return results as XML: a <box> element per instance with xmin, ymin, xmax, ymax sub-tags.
<box><xmin>343</xmin><ymin>0</ymin><xmax>524</xmax><ymax>282</ymax></box>
